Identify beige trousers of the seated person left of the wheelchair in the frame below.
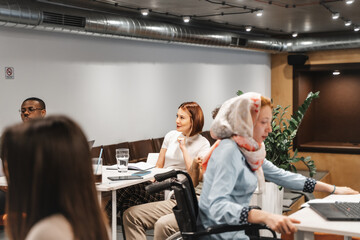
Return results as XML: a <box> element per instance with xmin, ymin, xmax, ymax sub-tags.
<box><xmin>123</xmin><ymin>200</ymin><xmax>179</xmax><ymax>240</ymax></box>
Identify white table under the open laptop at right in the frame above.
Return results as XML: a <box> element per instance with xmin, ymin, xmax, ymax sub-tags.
<box><xmin>289</xmin><ymin>194</ymin><xmax>360</xmax><ymax>240</ymax></box>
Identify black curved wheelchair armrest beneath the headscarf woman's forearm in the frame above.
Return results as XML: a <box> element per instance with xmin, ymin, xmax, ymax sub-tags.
<box><xmin>181</xmin><ymin>223</ymin><xmax>276</xmax><ymax>239</ymax></box>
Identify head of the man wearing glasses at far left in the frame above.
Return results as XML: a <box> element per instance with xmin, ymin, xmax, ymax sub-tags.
<box><xmin>20</xmin><ymin>97</ymin><xmax>46</xmax><ymax>122</ymax></box>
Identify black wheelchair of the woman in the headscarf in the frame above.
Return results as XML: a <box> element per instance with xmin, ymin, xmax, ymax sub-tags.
<box><xmin>146</xmin><ymin>170</ymin><xmax>277</xmax><ymax>240</ymax></box>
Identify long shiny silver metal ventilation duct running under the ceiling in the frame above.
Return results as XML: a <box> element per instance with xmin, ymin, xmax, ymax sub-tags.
<box><xmin>0</xmin><ymin>0</ymin><xmax>360</xmax><ymax>52</ymax></box>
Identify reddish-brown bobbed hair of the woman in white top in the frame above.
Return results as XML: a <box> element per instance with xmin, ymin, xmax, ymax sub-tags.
<box><xmin>178</xmin><ymin>102</ymin><xmax>204</xmax><ymax>137</ymax></box>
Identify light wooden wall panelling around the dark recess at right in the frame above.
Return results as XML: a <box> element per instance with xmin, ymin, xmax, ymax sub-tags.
<box><xmin>271</xmin><ymin>49</ymin><xmax>360</xmax><ymax>191</ymax></box>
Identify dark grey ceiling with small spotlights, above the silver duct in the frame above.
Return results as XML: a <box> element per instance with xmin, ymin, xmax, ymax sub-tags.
<box><xmin>38</xmin><ymin>0</ymin><xmax>360</xmax><ymax>38</ymax></box>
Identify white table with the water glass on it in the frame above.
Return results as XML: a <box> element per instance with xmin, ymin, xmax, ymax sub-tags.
<box><xmin>0</xmin><ymin>166</ymin><xmax>171</xmax><ymax>240</ymax></box>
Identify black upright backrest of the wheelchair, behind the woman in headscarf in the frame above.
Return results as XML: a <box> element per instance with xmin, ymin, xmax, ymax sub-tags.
<box><xmin>172</xmin><ymin>173</ymin><xmax>199</xmax><ymax>232</ymax></box>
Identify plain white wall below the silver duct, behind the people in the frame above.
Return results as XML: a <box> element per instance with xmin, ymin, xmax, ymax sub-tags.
<box><xmin>0</xmin><ymin>27</ymin><xmax>270</xmax><ymax>145</ymax></box>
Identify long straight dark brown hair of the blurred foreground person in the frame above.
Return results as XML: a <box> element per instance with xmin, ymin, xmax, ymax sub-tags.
<box><xmin>1</xmin><ymin>116</ymin><xmax>109</xmax><ymax>240</ymax></box>
